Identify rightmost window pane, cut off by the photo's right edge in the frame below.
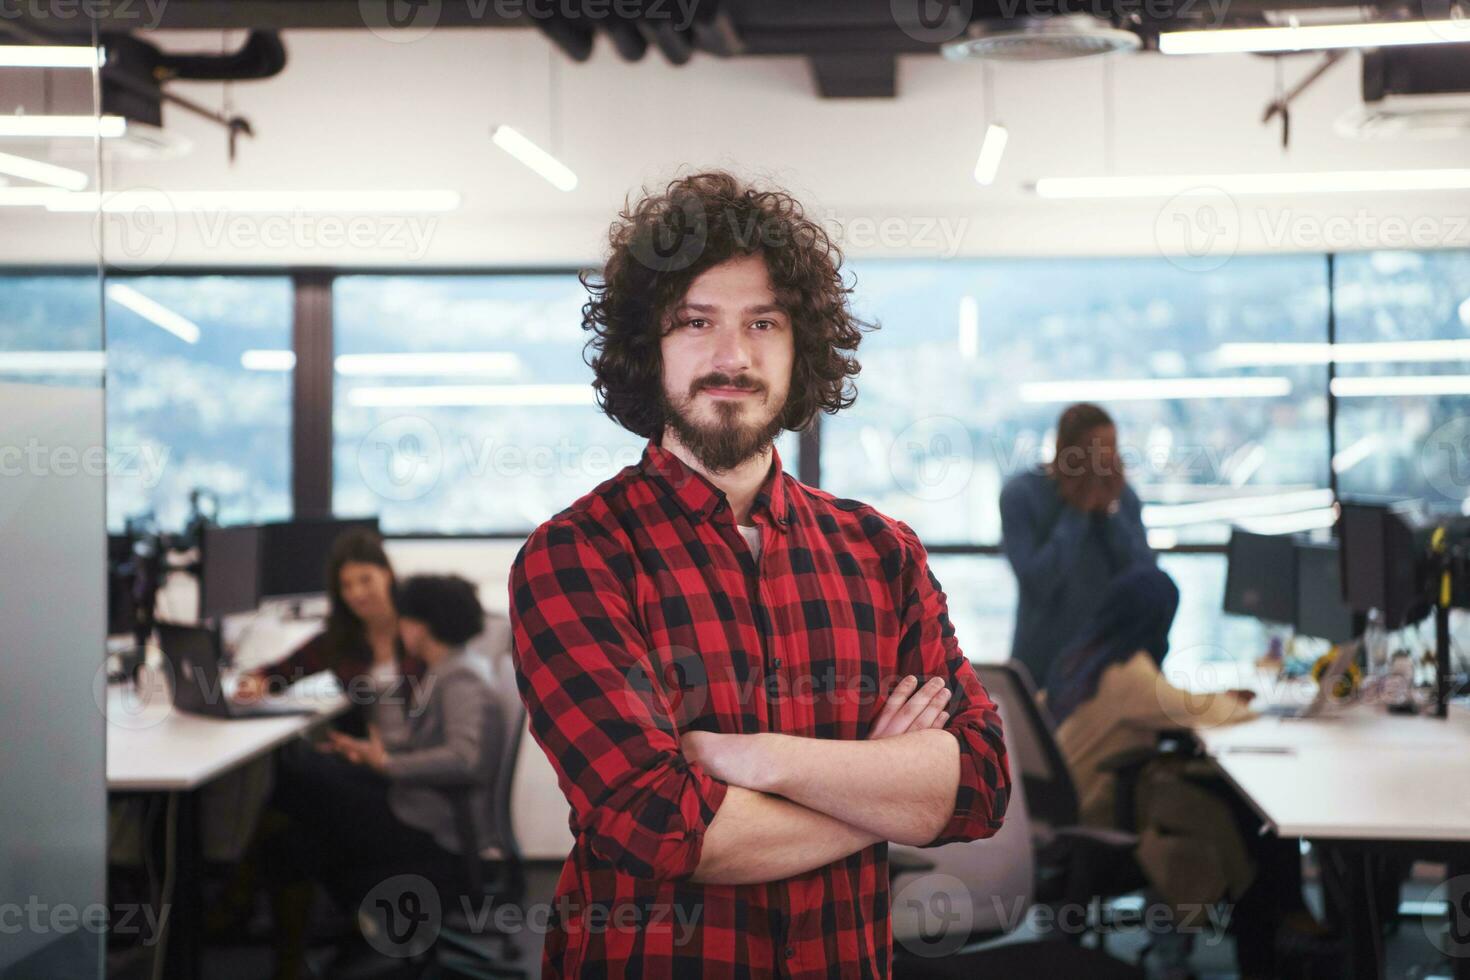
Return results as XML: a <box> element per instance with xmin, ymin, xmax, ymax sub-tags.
<box><xmin>1333</xmin><ymin>251</ymin><xmax>1470</xmax><ymax>511</ymax></box>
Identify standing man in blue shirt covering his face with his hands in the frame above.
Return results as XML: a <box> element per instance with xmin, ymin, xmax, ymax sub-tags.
<box><xmin>1001</xmin><ymin>403</ymin><xmax>1155</xmax><ymax>686</ymax></box>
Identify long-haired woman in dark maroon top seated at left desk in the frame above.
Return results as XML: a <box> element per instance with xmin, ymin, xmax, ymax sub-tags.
<box><xmin>235</xmin><ymin>529</ymin><xmax>423</xmax><ymax>736</ymax></box>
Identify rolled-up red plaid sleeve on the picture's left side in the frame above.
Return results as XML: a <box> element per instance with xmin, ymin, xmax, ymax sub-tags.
<box><xmin>510</xmin><ymin>522</ymin><xmax>728</xmax><ymax>880</ymax></box>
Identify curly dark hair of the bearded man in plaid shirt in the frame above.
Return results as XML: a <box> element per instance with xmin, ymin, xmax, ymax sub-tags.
<box><xmin>581</xmin><ymin>170</ymin><xmax>876</xmax><ymax>438</ymax></box>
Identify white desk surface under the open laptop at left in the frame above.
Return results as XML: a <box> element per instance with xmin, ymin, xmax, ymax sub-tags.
<box><xmin>107</xmin><ymin>688</ymin><xmax>347</xmax><ymax>792</ymax></box>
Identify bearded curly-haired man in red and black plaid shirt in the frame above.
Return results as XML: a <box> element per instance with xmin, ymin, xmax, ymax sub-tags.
<box><xmin>510</xmin><ymin>172</ymin><xmax>1010</xmax><ymax>977</ymax></box>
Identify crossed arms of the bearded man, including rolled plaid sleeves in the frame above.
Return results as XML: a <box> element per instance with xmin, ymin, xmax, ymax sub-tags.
<box><xmin>510</xmin><ymin>523</ymin><xmax>1010</xmax><ymax>884</ymax></box>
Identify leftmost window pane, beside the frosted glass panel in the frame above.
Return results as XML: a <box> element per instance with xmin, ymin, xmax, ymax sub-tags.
<box><xmin>94</xmin><ymin>275</ymin><xmax>293</xmax><ymax>530</ymax></box>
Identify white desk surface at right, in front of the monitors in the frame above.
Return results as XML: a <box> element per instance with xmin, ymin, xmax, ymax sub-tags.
<box><xmin>1200</xmin><ymin>690</ymin><xmax>1470</xmax><ymax>842</ymax></box>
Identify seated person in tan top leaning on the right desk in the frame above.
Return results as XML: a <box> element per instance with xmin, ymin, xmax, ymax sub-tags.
<box><xmin>1042</xmin><ymin>564</ymin><xmax>1322</xmax><ymax>979</ymax></box>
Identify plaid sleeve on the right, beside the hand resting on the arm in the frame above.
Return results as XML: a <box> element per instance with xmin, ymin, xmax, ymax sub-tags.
<box><xmin>898</xmin><ymin>522</ymin><xmax>1011</xmax><ymax>848</ymax></box>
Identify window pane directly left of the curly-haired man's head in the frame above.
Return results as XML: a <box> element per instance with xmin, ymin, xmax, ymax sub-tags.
<box><xmin>332</xmin><ymin>273</ymin><xmax>797</xmax><ymax>533</ymax></box>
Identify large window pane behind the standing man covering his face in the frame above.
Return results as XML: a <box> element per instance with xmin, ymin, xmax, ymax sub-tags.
<box><xmin>822</xmin><ymin>256</ymin><xmax>1330</xmax><ymax>545</ymax></box>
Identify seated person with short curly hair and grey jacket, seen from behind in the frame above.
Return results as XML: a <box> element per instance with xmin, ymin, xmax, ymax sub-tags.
<box><xmin>268</xmin><ymin>576</ymin><xmax>503</xmax><ymax>977</ymax></box>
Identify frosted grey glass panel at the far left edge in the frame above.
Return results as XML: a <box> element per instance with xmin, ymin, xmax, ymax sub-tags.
<box><xmin>0</xmin><ymin>382</ymin><xmax>107</xmax><ymax>980</ymax></box>
